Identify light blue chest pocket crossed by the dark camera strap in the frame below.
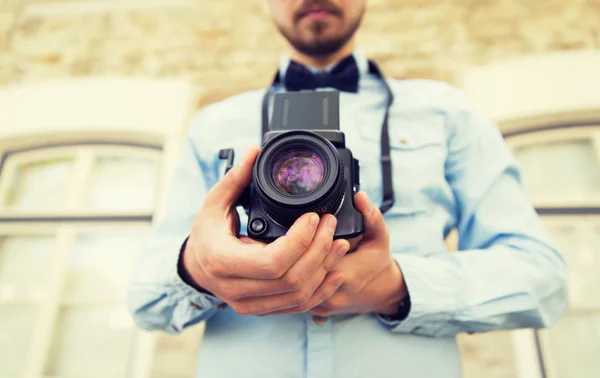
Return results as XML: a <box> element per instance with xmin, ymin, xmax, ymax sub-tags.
<box><xmin>360</xmin><ymin>115</ymin><xmax>447</xmax><ymax>215</ymax></box>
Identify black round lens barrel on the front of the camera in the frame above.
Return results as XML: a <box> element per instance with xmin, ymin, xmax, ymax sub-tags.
<box><xmin>253</xmin><ymin>130</ymin><xmax>346</xmax><ymax>227</ymax></box>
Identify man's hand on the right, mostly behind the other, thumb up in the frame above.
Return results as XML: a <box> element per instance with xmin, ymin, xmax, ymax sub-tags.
<box><xmin>270</xmin><ymin>192</ymin><xmax>407</xmax><ymax>316</ymax></box>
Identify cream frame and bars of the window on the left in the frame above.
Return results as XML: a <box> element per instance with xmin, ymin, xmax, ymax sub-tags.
<box><xmin>0</xmin><ymin>139</ymin><xmax>163</xmax><ymax>378</ymax></box>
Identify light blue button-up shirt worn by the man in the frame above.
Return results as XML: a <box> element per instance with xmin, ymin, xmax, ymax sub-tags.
<box><xmin>129</xmin><ymin>50</ymin><xmax>568</xmax><ymax>378</ymax></box>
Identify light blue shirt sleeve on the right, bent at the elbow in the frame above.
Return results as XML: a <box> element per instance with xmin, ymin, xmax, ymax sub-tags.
<box><xmin>378</xmin><ymin>88</ymin><xmax>568</xmax><ymax>337</ymax></box>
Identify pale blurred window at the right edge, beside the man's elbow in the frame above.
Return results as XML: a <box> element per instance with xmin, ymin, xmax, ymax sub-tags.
<box><xmin>507</xmin><ymin>124</ymin><xmax>600</xmax><ymax>378</ymax></box>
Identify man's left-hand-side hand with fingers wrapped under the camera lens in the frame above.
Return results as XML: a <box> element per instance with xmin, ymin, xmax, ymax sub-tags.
<box><xmin>183</xmin><ymin>148</ymin><xmax>350</xmax><ymax>315</ymax></box>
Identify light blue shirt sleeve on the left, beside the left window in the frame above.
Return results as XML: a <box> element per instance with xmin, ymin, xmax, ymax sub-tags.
<box><xmin>128</xmin><ymin>112</ymin><xmax>223</xmax><ymax>333</ymax></box>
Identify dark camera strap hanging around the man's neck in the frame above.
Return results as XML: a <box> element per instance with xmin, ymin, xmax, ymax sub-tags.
<box><xmin>262</xmin><ymin>60</ymin><xmax>394</xmax><ymax>214</ymax></box>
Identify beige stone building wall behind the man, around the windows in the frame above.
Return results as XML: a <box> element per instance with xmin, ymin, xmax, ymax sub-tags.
<box><xmin>0</xmin><ymin>0</ymin><xmax>600</xmax><ymax>378</ymax></box>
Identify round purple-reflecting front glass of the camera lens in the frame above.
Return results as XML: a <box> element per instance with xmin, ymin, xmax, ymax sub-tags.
<box><xmin>273</xmin><ymin>149</ymin><xmax>325</xmax><ymax>195</ymax></box>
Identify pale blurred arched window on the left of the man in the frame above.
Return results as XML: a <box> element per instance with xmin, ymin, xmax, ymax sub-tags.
<box><xmin>0</xmin><ymin>143</ymin><xmax>199</xmax><ymax>378</ymax></box>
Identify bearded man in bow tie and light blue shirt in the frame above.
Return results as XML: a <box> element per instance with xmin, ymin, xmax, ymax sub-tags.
<box><xmin>130</xmin><ymin>0</ymin><xmax>567</xmax><ymax>378</ymax></box>
